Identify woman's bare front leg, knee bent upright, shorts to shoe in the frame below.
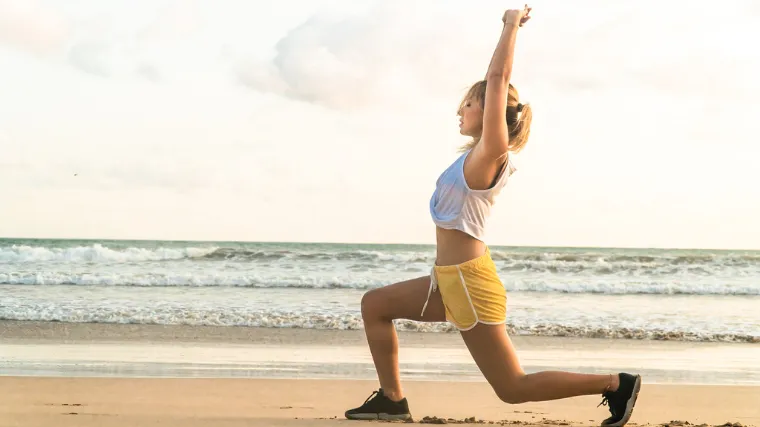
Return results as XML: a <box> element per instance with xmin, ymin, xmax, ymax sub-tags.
<box><xmin>362</xmin><ymin>276</ymin><xmax>446</xmax><ymax>401</ymax></box>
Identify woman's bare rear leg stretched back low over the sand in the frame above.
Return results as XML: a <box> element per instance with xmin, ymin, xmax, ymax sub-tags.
<box><xmin>462</xmin><ymin>324</ymin><xmax>619</xmax><ymax>403</ymax></box>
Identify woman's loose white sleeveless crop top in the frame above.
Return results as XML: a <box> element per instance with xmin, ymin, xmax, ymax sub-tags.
<box><xmin>430</xmin><ymin>150</ymin><xmax>517</xmax><ymax>241</ymax></box>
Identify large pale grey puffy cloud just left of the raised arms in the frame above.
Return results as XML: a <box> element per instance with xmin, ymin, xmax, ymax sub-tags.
<box><xmin>237</xmin><ymin>0</ymin><xmax>500</xmax><ymax>110</ymax></box>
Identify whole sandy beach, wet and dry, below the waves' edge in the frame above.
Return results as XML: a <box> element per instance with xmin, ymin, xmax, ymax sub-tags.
<box><xmin>0</xmin><ymin>321</ymin><xmax>760</xmax><ymax>427</ymax></box>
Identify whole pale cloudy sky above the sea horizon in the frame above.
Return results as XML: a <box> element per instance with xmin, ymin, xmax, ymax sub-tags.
<box><xmin>0</xmin><ymin>0</ymin><xmax>760</xmax><ymax>249</ymax></box>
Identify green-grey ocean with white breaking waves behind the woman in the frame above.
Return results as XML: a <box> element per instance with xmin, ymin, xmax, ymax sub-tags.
<box><xmin>0</xmin><ymin>239</ymin><xmax>760</xmax><ymax>343</ymax></box>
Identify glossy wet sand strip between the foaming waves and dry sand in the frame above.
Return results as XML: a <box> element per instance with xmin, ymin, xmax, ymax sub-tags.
<box><xmin>0</xmin><ymin>321</ymin><xmax>760</xmax><ymax>386</ymax></box>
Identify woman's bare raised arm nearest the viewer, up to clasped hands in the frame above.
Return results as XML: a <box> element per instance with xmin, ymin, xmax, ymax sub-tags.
<box><xmin>478</xmin><ymin>5</ymin><xmax>530</xmax><ymax>158</ymax></box>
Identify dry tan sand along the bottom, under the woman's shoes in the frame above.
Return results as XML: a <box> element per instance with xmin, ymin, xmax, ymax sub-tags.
<box><xmin>0</xmin><ymin>377</ymin><xmax>760</xmax><ymax>427</ymax></box>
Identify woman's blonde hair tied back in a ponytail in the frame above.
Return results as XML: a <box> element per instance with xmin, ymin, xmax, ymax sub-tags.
<box><xmin>457</xmin><ymin>80</ymin><xmax>533</xmax><ymax>153</ymax></box>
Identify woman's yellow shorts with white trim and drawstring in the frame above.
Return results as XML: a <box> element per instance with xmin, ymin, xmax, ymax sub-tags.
<box><xmin>422</xmin><ymin>249</ymin><xmax>507</xmax><ymax>331</ymax></box>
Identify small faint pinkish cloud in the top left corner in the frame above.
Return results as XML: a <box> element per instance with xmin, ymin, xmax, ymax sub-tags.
<box><xmin>0</xmin><ymin>0</ymin><xmax>69</xmax><ymax>55</ymax></box>
